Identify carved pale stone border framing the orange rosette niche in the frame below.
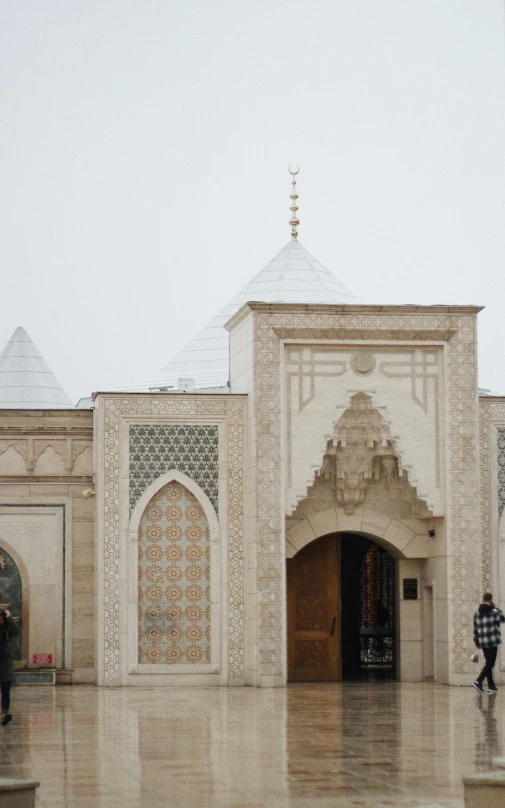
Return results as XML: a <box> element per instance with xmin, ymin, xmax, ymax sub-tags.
<box><xmin>95</xmin><ymin>393</ymin><xmax>246</xmax><ymax>685</ymax></box>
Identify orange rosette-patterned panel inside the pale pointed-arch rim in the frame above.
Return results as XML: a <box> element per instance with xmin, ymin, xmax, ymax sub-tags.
<box><xmin>138</xmin><ymin>481</ymin><xmax>211</xmax><ymax>664</ymax></box>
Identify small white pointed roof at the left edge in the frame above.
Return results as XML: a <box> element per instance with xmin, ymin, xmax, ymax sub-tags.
<box><xmin>0</xmin><ymin>327</ymin><xmax>73</xmax><ymax>410</ymax></box>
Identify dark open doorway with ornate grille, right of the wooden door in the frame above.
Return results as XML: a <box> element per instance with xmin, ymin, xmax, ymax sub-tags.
<box><xmin>340</xmin><ymin>533</ymin><xmax>396</xmax><ymax>680</ymax></box>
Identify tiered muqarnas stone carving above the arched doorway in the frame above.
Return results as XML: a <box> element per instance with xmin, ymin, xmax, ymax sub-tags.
<box><xmin>318</xmin><ymin>393</ymin><xmax>401</xmax><ymax>514</ymax></box>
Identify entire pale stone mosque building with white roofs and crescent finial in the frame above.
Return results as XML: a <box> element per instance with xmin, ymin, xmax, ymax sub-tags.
<box><xmin>0</xmin><ymin>171</ymin><xmax>505</xmax><ymax>687</ymax></box>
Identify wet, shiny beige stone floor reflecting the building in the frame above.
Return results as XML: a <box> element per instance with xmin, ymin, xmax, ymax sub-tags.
<box><xmin>0</xmin><ymin>683</ymin><xmax>505</xmax><ymax>808</ymax></box>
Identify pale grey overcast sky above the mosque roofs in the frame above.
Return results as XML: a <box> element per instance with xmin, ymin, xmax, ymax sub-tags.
<box><xmin>0</xmin><ymin>0</ymin><xmax>505</xmax><ymax>401</ymax></box>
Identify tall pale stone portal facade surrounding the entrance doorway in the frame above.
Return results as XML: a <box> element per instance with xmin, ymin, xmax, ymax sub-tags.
<box><xmin>227</xmin><ymin>303</ymin><xmax>481</xmax><ymax>685</ymax></box>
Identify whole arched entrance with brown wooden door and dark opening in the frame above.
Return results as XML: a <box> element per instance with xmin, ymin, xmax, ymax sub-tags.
<box><xmin>287</xmin><ymin>533</ymin><xmax>396</xmax><ymax>682</ymax></box>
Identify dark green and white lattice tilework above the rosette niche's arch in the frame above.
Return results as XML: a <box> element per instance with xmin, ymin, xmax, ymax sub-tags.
<box><xmin>129</xmin><ymin>424</ymin><xmax>218</xmax><ymax>514</ymax></box>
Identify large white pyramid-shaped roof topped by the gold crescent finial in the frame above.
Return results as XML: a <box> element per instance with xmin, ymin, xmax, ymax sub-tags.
<box><xmin>122</xmin><ymin>241</ymin><xmax>359</xmax><ymax>390</ymax></box>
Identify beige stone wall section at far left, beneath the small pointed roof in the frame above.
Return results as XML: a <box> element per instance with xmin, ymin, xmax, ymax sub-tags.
<box><xmin>0</xmin><ymin>410</ymin><xmax>96</xmax><ymax>683</ymax></box>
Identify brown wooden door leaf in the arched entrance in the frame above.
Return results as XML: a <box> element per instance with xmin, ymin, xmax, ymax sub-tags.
<box><xmin>287</xmin><ymin>534</ymin><xmax>342</xmax><ymax>682</ymax></box>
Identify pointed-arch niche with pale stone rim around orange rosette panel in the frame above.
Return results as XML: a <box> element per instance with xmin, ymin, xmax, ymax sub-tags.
<box><xmin>129</xmin><ymin>470</ymin><xmax>220</xmax><ymax>673</ymax></box>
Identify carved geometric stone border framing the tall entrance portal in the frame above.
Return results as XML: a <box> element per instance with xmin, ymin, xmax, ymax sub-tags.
<box><xmin>251</xmin><ymin>304</ymin><xmax>480</xmax><ymax>684</ymax></box>
